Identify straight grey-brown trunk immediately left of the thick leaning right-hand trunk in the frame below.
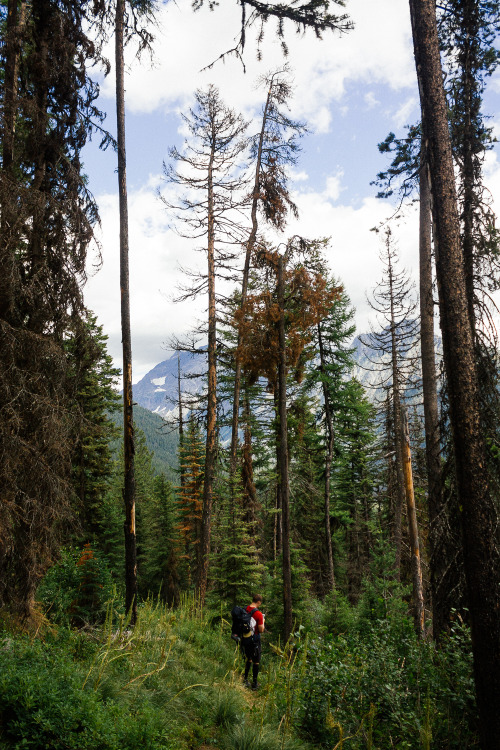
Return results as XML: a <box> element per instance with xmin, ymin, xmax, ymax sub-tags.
<box><xmin>419</xmin><ymin>140</ymin><xmax>446</xmax><ymax>639</ymax></box>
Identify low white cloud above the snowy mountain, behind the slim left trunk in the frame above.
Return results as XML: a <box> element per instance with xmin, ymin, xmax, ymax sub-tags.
<box><xmin>85</xmin><ymin>180</ymin><xmax>204</xmax><ymax>381</ymax></box>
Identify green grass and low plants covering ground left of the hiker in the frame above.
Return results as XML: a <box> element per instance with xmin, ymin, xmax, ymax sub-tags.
<box><xmin>0</xmin><ymin>601</ymin><xmax>312</xmax><ymax>750</ymax></box>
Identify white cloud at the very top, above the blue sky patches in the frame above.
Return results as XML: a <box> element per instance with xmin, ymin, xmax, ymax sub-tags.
<box><xmin>99</xmin><ymin>0</ymin><xmax>415</xmax><ymax>132</ymax></box>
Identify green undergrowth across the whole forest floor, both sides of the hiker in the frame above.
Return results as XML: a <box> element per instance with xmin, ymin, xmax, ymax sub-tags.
<box><xmin>0</xmin><ymin>600</ymin><xmax>477</xmax><ymax>750</ymax></box>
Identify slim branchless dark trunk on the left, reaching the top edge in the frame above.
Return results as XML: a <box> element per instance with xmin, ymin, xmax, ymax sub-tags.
<box><xmin>115</xmin><ymin>0</ymin><xmax>137</xmax><ymax>625</ymax></box>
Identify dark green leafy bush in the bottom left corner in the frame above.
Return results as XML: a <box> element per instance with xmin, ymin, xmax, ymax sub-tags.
<box><xmin>0</xmin><ymin>638</ymin><xmax>165</xmax><ymax>750</ymax></box>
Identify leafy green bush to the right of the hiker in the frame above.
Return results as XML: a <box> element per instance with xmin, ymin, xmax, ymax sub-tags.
<box><xmin>294</xmin><ymin>620</ymin><xmax>478</xmax><ymax>750</ymax></box>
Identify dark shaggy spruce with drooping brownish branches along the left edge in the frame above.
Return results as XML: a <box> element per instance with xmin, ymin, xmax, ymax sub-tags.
<box><xmin>0</xmin><ymin>0</ymin><xmax>106</xmax><ymax>615</ymax></box>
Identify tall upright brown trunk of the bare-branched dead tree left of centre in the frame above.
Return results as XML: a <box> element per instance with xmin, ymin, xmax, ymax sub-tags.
<box><xmin>197</xmin><ymin>150</ymin><xmax>217</xmax><ymax>604</ymax></box>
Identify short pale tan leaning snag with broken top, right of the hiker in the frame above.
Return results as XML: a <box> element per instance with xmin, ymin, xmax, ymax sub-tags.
<box><xmin>401</xmin><ymin>410</ymin><xmax>425</xmax><ymax>638</ymax></box>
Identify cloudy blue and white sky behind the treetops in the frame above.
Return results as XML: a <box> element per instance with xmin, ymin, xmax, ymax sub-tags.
<box><xmin>83</xmin><ymin>0</ymin><xmax>500</xmax><ymax>382</ymax></box>
